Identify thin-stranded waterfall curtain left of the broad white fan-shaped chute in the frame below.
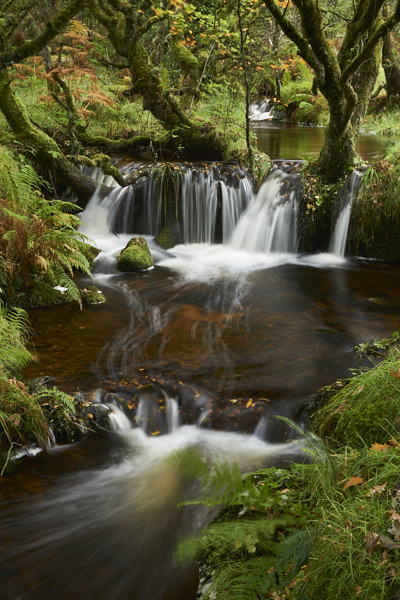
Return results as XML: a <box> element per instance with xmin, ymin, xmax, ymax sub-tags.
<box><xmin>81</xmin><ymin>165</ymin><xmax>252</xmax><ymax>244</ymax></box>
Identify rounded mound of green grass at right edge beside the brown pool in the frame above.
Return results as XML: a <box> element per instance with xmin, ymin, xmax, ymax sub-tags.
<box><xmin>311</xmin><ymin>348</ymin><xmax>400</xmax><ymax>448</ymax></box>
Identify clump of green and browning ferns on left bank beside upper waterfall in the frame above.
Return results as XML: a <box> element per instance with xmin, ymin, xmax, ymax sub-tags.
<box><xmin>0</xmin><ymin>157</ymin><xmax>90</xmax><ymax>304</ymax></box>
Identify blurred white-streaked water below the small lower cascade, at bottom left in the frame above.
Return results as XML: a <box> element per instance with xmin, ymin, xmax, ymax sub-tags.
<box><xmin>0</xmin><ymin>426</ymin><xmax>308</xmax><ymax>600</ymax></box>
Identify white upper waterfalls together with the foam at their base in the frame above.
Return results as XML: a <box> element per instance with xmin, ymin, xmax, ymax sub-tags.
<box><xmin>81</xmin><ymin>167</ymin><xmax>361</xmax><ymax>282</ymax></box>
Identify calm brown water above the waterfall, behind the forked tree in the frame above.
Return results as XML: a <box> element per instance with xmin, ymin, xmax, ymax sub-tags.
<box><xmin>252</xmin><ymin>121</ymin><xmax>394</xmax><ymax>164</ymax></box>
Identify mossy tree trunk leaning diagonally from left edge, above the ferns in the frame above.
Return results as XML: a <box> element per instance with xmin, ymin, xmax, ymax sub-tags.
<box><xmin>0</xmin><ymin>69</ymin><xmax>96</xmax><ymax>208</ymax></box>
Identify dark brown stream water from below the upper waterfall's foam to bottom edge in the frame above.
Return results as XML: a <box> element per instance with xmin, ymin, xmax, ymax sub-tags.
<box><xmin>0</xmin><ymin>258</ymin><xmax>400</xmax><ymax>600</ymax></box>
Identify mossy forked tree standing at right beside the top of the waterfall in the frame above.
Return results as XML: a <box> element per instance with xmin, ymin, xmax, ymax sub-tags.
<box><xmin>264</xmin><ymin>0</ymin><xmax>400</xmax><ymax>182</ymax></box>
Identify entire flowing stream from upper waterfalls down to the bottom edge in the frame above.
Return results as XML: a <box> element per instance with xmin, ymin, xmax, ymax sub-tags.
<box><xmin>0</xmin><ymin>143</ymin><xmax>400</xmax><ymax>600</ymax></box>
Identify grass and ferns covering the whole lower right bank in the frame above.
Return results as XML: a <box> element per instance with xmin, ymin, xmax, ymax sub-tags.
<box><xmin>184</xmin><ymin>342</ymin><xmax>400</xmax><ymax>600</ymax></box>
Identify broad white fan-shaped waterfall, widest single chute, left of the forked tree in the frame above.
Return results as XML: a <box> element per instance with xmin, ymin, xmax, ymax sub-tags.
<box><xmin>230</xmin><ymin>170</ymin><xmax>300</xmax><ymax>254</ymax></box>
